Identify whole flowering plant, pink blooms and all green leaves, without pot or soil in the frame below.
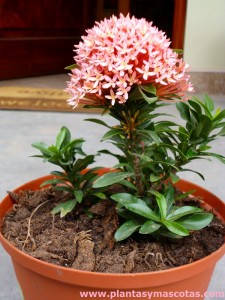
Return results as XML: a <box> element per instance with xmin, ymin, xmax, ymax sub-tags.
<box><xmin>33</xmin><ymin>15</ymin><xmax>225</xmax><ymax>241</ymax></box>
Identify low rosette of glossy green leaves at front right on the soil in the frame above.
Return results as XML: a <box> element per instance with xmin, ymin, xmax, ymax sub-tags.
<box><xmin>111</xmin><ymin>185</ymin><xmax>213</xmax><ymax>241</ymax></box>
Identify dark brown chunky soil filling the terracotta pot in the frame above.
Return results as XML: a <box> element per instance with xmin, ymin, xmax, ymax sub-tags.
<box><xmin>2</xmin><ymin>189</ymin><xmax>225</xmax><ymax>273</ymax></box>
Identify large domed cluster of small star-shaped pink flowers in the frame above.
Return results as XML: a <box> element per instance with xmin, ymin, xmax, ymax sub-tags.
<box><xmin>66</xmin><ymin>15</ymin><xmax>193</xmax><ymax>107</ymax></box>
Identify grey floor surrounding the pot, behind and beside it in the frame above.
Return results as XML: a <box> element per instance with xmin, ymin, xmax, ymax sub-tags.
<box><xmin>0</xmin><ymin>74</ymin><xmax>225</xmax><ymax>300</ymax></box>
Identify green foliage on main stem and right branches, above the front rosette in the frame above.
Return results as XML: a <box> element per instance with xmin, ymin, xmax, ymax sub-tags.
<box><xmin>92</xmin><ymin>95</ymin><xmax>225</xmax><ymax>197</ymax></box>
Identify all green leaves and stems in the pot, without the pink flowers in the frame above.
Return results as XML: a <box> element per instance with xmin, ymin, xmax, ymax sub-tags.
<box><xmin>32</xmin><ymin>93</ymin><xmax>225</xmax><ymax>241</ymax></box>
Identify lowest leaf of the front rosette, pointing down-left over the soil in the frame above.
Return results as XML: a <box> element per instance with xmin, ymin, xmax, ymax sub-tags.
<box><xmin>115</xmin><ymin>220</ymin><xmax>141</xmax><ymax>242</ymax></box>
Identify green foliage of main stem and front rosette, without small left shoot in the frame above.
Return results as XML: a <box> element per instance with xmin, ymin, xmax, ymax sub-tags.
<box><xmin>90</xmin><ymin>94</ymin><xmax>225</xmax><ymax>241</ymax></box>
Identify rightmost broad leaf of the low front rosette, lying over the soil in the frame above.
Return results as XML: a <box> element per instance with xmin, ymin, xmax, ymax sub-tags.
<box><xmin>179</xmin><ymin>213</ymin><xmax>213</xmax><ymax>230</ymax></box>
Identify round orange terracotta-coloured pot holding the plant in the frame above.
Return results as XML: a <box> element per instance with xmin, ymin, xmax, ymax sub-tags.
<box><xmin>0</xmin><ymin>176</ymin><xmax>225</xmax><ymax>300</ymax></box>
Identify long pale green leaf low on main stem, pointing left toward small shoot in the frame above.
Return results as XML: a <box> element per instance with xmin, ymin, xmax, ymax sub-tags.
<box><xmin>93</xmin><ymin>172</ymin><xmax>132</xmax><ymax>188</ymax></box>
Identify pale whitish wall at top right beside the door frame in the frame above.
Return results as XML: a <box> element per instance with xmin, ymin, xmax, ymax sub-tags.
<box><xmin>184</xmin><ymin>0</ymin><xmax>225</xmax><ymax>72</ymax></box>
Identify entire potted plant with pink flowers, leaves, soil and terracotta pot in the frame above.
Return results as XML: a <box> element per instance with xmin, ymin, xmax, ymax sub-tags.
<box><xmin>0</xmin><ymin>15</ymin><xmax>225</xmax><ymax>300</ymax></box>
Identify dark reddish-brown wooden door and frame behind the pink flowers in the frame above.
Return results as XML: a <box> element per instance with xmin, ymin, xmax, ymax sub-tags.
<box><xmin>0</xmin><ymin>0</ymin><xmax>187</xmax><ymax>80</ymax></box>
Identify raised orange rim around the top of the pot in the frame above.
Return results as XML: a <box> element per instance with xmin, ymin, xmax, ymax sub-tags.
<box><xmin>0</xmin><ymin>175</ymin><xmax>225</xmax><ymax>289</ymax></box>
